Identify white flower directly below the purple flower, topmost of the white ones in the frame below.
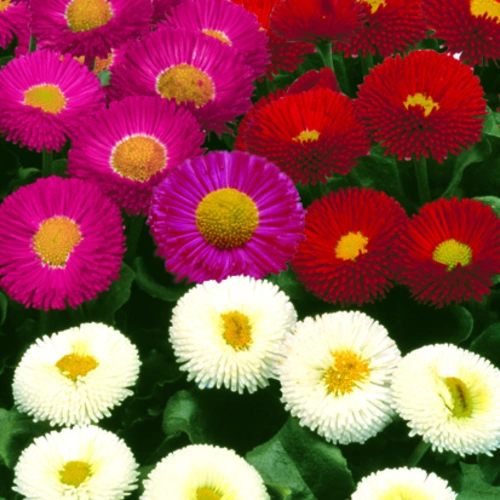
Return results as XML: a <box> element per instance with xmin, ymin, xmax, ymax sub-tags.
<box><xmin>170</xmin><ymin>276</ymin><xmax>297</xmax><ymax>393</ymax></box>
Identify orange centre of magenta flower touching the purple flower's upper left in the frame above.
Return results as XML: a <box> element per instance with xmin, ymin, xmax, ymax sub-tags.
<box><xmin>111</xmin><ymin>135</ymin><xmax>167</xmax><ymax>182</ymax></box>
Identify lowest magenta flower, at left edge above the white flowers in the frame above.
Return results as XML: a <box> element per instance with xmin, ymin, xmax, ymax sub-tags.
<box><xmin>0</xmin><ymin>176</ymin><xmax>125</xmax><ymax>311</ymax></box>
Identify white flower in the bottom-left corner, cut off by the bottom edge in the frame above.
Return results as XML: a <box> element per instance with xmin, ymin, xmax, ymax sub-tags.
<box><xmin>13</xmin><ymin>425</ymin><xmax>139</xmax><ymax>500</ymax></box>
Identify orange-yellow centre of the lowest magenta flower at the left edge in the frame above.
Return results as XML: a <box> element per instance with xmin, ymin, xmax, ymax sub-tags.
<box><xmin>33</xmin><ymin>217</ymin><xmax>82</xmax><ymax>267</ymax></box>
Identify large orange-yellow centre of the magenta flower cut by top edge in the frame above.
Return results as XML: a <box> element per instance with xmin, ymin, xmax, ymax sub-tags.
<box><xmin>66</xmin><ymin>0</ymin><xmax>113</xmax><ymax>33</ymax></box>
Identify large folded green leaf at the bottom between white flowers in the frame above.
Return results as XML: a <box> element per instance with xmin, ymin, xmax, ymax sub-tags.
<box><xmin>246</xmin><ymin>418</ymin><xmax>354</xmax><ymax>500</ymax></box>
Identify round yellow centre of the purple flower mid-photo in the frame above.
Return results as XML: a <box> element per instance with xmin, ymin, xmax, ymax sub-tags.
<box><xmin>196</xmin><ymin>188</ymin><xmax>259</xmax><ymax>249</ymax></box>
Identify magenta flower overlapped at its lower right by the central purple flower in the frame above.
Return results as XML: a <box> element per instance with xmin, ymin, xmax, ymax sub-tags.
<box><xmin>68</xmin><ymin>96</ymin><xmax>205</xmax><ymax>215</ymax></box>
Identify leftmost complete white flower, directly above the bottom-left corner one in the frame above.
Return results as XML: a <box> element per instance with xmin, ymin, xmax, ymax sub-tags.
<box><xmin>13</xmin><ymin>323</ymin><xmax>140</xmax><ymax>426</ymax></box>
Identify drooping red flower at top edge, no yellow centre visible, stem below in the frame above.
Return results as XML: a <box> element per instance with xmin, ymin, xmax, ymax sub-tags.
<box><xmin>271</xmin><ymin>0</ymin><xmax>364</xmax><ymax>43</ymax></box>
